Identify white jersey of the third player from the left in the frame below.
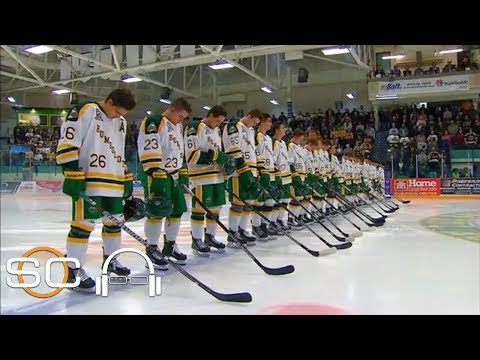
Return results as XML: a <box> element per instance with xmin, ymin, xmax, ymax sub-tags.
<box><xmin>185</xmin><ymin>121</ymin><xmax>225</xmax><ymax>186</ymax></box>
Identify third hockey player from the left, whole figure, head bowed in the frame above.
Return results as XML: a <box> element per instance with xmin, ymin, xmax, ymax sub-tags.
<box><xmin>185</xmin><ymin>105</ymin><xmax>236</xmax><ymax>255</ymax></box>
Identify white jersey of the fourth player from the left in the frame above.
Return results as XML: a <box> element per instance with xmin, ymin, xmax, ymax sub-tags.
<box><xmin>222</xmin><ymin>121</ymin><xmax>258</xmax><ymax>176</ymax></box>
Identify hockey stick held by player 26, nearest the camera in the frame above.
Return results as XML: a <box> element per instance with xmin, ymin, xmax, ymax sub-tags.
<box><xmin>81</xmin><ymin>194</ymin><xmax>252</xmax><ymax>302</ymax></box>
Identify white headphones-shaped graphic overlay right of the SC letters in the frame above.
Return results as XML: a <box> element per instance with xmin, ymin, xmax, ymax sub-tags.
<box><xmin>95</xmin><ymin>248</ymin><xmax>162</xmax><ymax>297</ymax></box>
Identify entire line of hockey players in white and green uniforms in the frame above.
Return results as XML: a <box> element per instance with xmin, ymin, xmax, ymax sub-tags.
<box><xmin>57</xmin><ymin>91</ymin><xmax>384</xmax><ymax>291</ymax></box>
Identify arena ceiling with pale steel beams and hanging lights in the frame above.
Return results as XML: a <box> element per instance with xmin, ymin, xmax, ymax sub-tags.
<box><xmin>0</xmin><ymin>45</ymin><xmax>368</xmax><ymax>108</ymax></box>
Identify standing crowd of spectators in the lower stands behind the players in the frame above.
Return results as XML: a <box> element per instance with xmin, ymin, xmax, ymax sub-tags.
<box><xmin>8</xmin><ymin>100</ymin><xmax>480</xmax><ymax>180</ymax></box>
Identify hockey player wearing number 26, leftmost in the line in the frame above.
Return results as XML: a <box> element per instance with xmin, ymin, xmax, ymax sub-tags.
<box><xmin>56</xmin><ymin>89</ymin><xmax>136</xmax><ymax>292</ymax></box>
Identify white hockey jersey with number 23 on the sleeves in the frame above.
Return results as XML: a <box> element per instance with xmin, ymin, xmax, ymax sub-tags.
<box><xmin>137</xmin><ymin>116</ymin><xmax>184</xmax><ymax>178</ymax></box>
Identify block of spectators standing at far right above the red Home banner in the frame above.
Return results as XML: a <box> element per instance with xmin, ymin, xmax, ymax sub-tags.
<box><xmin>378</xmin><ymin>105</ymin><xmax>480</xmax><ymax>177</ymax></box>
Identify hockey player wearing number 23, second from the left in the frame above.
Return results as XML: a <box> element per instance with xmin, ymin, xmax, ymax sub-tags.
<box><xmin>138</xmin><ymin>98</ymin><xmax>192</xmax><ymax>270</ymax></box>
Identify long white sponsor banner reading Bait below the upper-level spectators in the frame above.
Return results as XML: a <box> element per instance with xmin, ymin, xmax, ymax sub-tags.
<box><xmin>378</xmin><ymin>75</ymin><xmax>470</xmax><ymax>96</ymax></box>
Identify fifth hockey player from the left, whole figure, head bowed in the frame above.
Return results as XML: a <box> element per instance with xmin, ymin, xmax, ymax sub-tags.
<box><xmin>252</xmin><ymin>114</ymin><xmax>284</xmax><ymax>241</ymax></box>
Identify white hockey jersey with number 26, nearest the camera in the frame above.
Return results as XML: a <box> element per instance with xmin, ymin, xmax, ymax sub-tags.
<box><xmin>57</xmin><ymin>102</ymin><xmax>127</xmax><ymax>197</ymax></box>
